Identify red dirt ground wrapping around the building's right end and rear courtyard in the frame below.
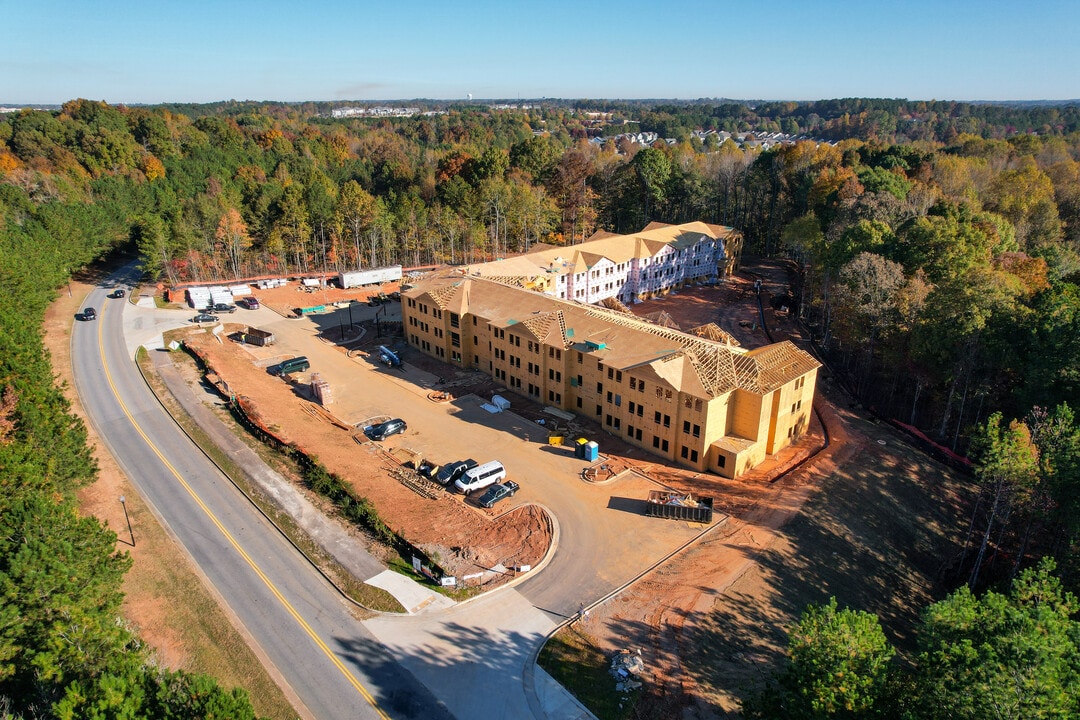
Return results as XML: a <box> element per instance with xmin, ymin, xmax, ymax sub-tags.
<box><xmin>575</xmin><ymin>263</ymin><xmax>966</xmax><ymax>719</ymax></box>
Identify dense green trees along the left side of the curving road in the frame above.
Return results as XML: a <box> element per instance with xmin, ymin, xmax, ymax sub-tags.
<box><xmin>0</xmin><ymin>106</ymin><xmax>255</xmax><ymax>720</ymax></box>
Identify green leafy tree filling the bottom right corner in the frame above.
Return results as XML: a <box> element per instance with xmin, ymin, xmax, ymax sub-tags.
<box><xmin>917</xmin><ymin>559</ymin><xmax>1080</xmax><ymax>720</ymax></box>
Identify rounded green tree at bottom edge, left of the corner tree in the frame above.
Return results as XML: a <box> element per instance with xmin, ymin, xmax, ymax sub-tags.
<box><xmin>743</xmin><ymin>597</ymin><xmax>895</xmax><ymax>720</ymax></box>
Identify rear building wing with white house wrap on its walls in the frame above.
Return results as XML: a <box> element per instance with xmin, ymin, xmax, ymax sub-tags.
<box><xmin>465</xmin><ymin>222</ymin><xmax>742</xmax><ymax>304</ymax></box>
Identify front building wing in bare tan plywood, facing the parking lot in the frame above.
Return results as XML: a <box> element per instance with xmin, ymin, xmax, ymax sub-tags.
<box><xmin>402</xmin><ymin>274</ymin><xmax>820</xmax><ymax>477</ymax></box>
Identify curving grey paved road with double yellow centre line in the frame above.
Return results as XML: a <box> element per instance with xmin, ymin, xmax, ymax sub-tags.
<box><xmin>71</xmin><ymin>280</ymin><xmax>451</xmax><ymax>719</ymax></box>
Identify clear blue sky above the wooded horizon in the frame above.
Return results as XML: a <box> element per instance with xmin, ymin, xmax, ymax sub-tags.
<box><xmin>0</xmin><ymin>0</ymin><xmax>1080</xmax><ymax>105</ymax></box>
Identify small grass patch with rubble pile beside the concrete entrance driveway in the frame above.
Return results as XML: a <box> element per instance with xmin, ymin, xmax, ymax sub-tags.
<box><xmin>537</xmin><ymin>624</ymin><xmax>640</xmax><ymax>720</ymax></box>
